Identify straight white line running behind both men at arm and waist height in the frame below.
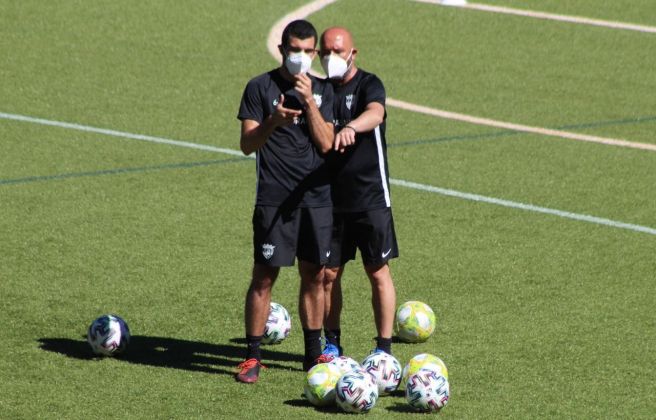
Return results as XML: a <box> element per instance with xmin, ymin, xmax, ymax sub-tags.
<box><xmin>0</xmin><ymin>112</ymin><xmax>656</xmax><ymax>235</ymax></box>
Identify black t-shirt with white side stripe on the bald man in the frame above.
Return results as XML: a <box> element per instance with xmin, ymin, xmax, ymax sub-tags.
<box><xmin>328</xmin><ymin>69</ymin><xmax>390</xmax><ymax>212</ymax></box>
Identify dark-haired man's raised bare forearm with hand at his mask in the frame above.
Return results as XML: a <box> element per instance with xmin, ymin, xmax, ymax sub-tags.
<box><xmin>294</xmin><ymin>74</ymin><xmax>335</xmax><ymax>153</ymax></box>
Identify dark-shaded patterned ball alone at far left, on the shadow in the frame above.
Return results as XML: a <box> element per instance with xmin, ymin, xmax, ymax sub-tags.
<box><xmin>87</xmin><ymin>315</ymin><xmax>130</xmax><ymax>356</ymax></box>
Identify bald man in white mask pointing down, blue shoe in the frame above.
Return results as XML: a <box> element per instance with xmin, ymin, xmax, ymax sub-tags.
<box><xmin>320</xmin><ymin>27</ymin><xmax>399</xmax><ymax>358</ymax></box>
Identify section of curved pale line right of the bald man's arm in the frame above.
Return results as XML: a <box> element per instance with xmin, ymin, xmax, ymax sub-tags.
<box><xmin>387</xmin><ymin>98</ymin><xmax>656</xmax><ymax>152</ymax></box>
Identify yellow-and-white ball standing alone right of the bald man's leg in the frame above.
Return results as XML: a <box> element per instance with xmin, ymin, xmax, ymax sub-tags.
<box><xmin>396</xmin><ymin>301</ymin><xmax>435</xmax><ymax>343</ymax></box>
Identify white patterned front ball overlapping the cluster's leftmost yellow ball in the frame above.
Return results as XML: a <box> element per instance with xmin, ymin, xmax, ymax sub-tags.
<box><xmin>335</xmin><ymin>368</ymin><xmax>378</xmax><ymax>413</ymax></box>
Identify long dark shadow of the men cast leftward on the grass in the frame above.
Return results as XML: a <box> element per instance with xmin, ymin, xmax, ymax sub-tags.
<box><xmin>38</xmin><ymin>335</ymin><xmax>303</xmax><ymax>375</ymax></box>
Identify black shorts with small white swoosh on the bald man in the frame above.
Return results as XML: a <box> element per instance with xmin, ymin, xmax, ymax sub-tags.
<box><xmin>326</xmin><ymin>207</ymin><xmax>399</xmax><ymax>267</ymax></box>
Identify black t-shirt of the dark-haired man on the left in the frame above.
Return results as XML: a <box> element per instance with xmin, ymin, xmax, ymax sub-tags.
<box><xmin>237</xmin><ymin>69</ymin><xmax>333</xmax><ymax>209</ymax></box>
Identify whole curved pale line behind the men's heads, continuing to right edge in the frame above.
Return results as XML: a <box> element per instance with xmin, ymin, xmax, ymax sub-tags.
<box><xmin>267</xmin><ymin>0</ymin><xmax>656</xmax><ymax>151</ymax></box>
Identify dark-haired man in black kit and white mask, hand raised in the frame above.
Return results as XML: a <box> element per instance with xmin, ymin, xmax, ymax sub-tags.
<box><xmin>236</xmin><ymin>20</ymin><xmax>334</xmax><ymax>383</ymax></box>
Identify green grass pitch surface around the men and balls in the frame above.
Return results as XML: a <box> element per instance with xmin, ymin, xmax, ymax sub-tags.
<box><xmin>0</xmin><ymin>0</ymin><xmax>656</xmax><ymax>419</ymax></box>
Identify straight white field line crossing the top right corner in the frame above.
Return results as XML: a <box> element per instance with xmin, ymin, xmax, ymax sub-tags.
<box><xmin>414</xmin><ymin>0</ymin><xmax>656</xmax><ymax>33</ymax></box>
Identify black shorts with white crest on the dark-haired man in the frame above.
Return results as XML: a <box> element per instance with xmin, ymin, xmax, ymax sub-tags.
<box><xmin>253</xmin><ymin>206</ymin><xmax>333</xmax><ymax>267</ymax></box>
